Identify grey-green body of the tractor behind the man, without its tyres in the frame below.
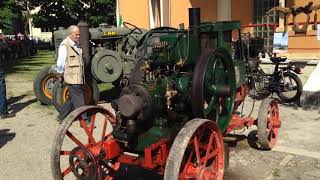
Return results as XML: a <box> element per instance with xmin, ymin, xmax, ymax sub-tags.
<box><xmin>54</xmin><ymin>24</ymin><xmax>147</xmax><ymax>84</ymax></box>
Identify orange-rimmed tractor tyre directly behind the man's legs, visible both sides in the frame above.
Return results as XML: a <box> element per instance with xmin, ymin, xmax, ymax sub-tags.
<box><xmin>52</xmin><ymin>80</ymin><xmax>100</xmax><ymax>112</ymax></box>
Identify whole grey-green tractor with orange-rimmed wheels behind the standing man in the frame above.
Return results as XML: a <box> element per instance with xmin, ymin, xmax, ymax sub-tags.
<box><xmin>33</xmin><ymin>23</ymin><xmax>146</xmax><ymax>107</ymax></box>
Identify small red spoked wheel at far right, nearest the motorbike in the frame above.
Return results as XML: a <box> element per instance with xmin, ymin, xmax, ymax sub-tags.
<box><xmin>258</xmin><ymin>98</ymin><xmax>281</xmax><ymax>150</ymax></box>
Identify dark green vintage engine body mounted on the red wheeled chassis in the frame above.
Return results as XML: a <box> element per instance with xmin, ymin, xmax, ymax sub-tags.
<box><xmin>113</xmin><ymin>8</ymin><xmax>245</xmax><ymax>151</ymax></box>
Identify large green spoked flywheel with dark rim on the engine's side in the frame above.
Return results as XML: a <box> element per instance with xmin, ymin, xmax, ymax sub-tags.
<box><xmin>192</xmin><ymin>49</ymin><xmax>236</xmax><ymax>132</ymax></box>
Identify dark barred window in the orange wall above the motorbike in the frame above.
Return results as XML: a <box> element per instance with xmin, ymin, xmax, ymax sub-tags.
<box><xmin>253</xmin><ymin>0</ymin><xmax>279</xmax><ymax>52</ymax></box>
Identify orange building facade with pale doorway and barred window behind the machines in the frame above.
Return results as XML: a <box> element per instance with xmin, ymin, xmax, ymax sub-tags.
<box><xmin>117</xmin><ymin>0</ymin><xmax>320</xmax><ymax>59</ymax></box>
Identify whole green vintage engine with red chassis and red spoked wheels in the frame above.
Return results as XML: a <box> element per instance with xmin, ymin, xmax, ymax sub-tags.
<box><xmin>51</xmin><ymin>8</ymin><xmax>280</xmax><ymax>180</ymax></box>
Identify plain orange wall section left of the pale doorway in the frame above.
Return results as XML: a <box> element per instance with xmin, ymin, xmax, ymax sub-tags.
<box><xmin>119</xmin><ymin>0</ymin><xmax>149</xmax><ymax>29</ymax></box>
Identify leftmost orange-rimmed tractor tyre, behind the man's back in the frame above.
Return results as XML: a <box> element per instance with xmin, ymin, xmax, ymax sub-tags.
<box><xmin>33</xmin><ymin>67</ymin><xmax>55</xmax><ymax>105</ymax></box>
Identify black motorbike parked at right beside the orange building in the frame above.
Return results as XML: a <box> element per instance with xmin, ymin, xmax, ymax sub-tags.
<box><xmin>248</xmin><ymin>52</ymin><xmax>302</xmax><ymax>103</ymax></box>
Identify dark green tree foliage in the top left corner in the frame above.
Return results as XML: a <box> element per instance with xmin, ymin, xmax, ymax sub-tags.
<box><xmin>0</xmin><ymin>0</ymin><xmax>21</xmax><ymax>34</ymax></box>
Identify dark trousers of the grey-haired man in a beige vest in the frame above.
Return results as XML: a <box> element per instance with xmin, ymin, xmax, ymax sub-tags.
<box><xmin>59</xmin><ymin>84</ymin><xmax>85</xmax><ymax>120</ymax></box>
